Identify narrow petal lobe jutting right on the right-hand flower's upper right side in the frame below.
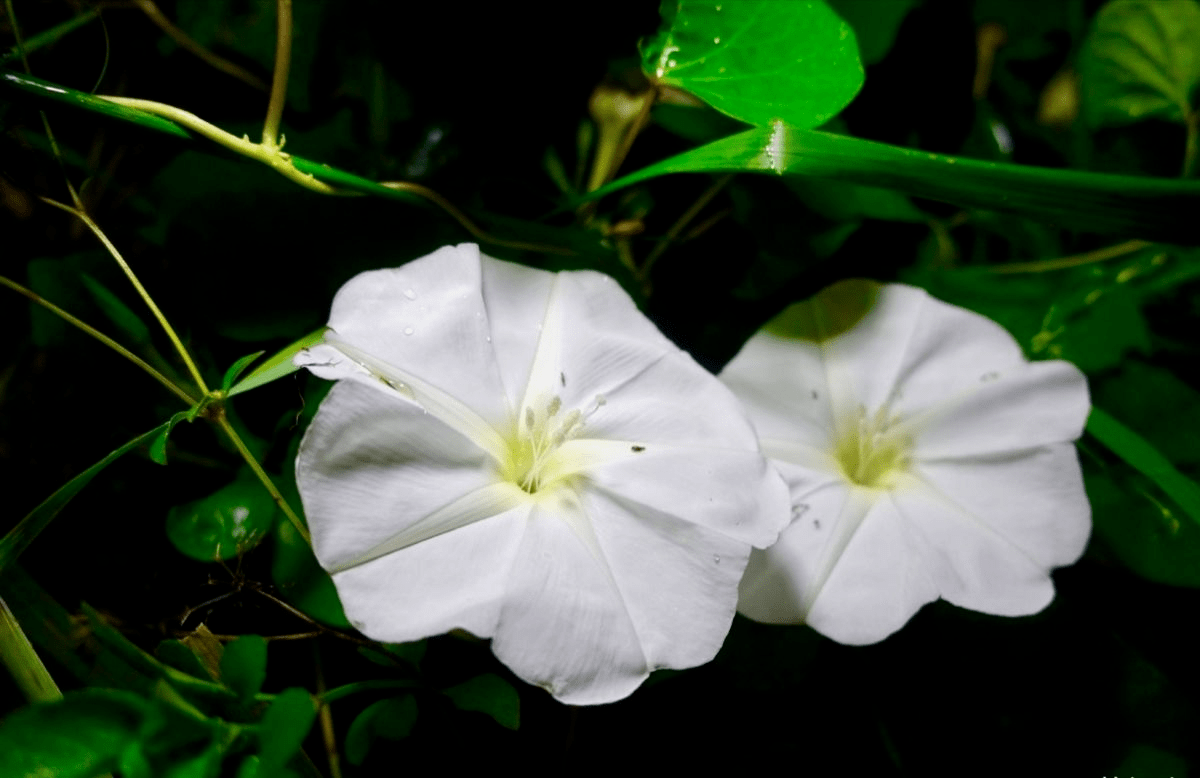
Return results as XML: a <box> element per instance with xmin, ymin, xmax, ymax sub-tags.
<box><xmin>912</xmin><ymin>361</ymin><xmax>1091</xmax><ymax>460</ymax></box>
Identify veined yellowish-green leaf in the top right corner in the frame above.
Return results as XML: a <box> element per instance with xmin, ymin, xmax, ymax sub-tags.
<box><xmin>1079</xmin><ymin>0</ymin><xmax>1200</xmax><ymax>127</ymax></box>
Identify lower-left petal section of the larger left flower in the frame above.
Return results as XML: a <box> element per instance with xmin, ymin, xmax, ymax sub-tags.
<box><xmin>334</xmin><ymin>503</ymin><xmax>529</xmax><ymax>642</ymax></box>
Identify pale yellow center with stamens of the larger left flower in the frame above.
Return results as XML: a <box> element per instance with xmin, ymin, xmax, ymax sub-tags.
<box><xmin>503</xmin><ymin>395</ymin><xmax>605</xmax><ymax>495</ymax></box>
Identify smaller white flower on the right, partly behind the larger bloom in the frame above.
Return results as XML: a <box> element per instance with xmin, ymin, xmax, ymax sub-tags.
<box><xmin>721</xmin><ymin>281</ymin><xmax>1091</xmax><ymax>644</ymax></box>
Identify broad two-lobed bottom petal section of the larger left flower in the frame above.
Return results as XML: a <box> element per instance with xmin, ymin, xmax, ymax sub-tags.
<box><xmin>492</xmin><ymin>495</ymin><xmax>748</xmax><ymax>705</ymax></box>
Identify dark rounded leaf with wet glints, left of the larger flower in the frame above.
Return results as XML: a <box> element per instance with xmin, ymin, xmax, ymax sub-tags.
<box><xmin>167</xmin><ymin>474</ymin><xmax>276</xmax><ymax>562</ymax></box>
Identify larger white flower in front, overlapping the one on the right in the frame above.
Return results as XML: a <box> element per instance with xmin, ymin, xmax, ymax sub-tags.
<box><xmin>296</xmin><ymin>245</ymin><xmax>788</xmax><ymax>705</ymax></box>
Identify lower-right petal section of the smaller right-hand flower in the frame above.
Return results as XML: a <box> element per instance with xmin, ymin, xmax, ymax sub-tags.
<box><xmin>892</xmin><ymin>470</ymin><xmax>1054</xmax><ymax>616</ymax></box>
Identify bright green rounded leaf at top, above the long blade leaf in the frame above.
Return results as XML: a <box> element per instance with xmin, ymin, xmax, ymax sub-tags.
<box><xmin>640</xmin><ymin>0</ymin><xmax>863</xmax><ymax>127</ymax></box>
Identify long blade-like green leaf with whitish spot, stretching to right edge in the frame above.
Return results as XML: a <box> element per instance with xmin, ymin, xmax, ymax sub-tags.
<box><xmin>578</xmin><ymin>122</ymin><xmax>1200</xmax><ymax>243</ymax></box>
